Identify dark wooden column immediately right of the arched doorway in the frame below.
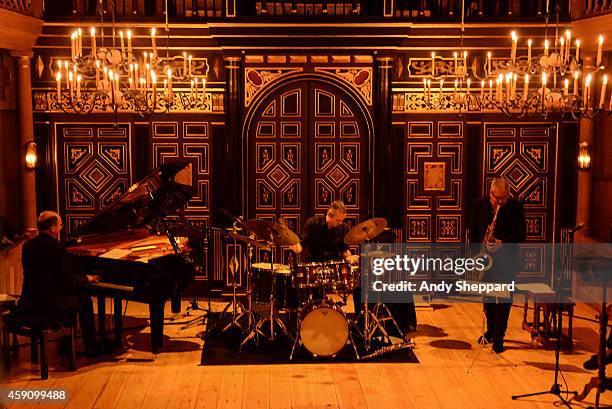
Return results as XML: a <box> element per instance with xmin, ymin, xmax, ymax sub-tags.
<box><xmin>373</xmin><ymin>57</ymin><xmax>402</xmax><ymax>223</ymax></box>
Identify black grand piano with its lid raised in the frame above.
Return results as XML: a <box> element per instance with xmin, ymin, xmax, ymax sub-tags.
<box><xmin>67</xmin><ymin>162</ymin><xmax>194</xmax><ymax>353</ymax></box>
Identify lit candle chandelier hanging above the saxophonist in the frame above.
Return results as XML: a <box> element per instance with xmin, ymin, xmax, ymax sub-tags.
<box><xmin>423</xmin><ymin>0</ymin><xmax>612</xmax><ymax>119</ymax></box>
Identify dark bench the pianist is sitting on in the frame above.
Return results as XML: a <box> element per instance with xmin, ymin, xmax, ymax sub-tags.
<box><xmin>2</xmin><ymin>316</ymin><xmax>76</xmax><ymax>379</ymax></box>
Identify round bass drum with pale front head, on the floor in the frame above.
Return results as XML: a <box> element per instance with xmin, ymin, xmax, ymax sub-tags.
<box><xmin>300</xmin><ymin>300</ymin><xmax>349</xmax><ymax>357</ymax></box>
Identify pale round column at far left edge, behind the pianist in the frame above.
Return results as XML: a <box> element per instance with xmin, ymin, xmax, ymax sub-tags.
<box><xmin>11</xmin><ymin>51</ymin><xmax>36</xmax><ymax>232</ymax></box>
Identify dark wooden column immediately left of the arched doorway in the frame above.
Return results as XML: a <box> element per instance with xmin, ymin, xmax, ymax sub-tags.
<box><xmin>223</xmin><ymin>56</ymin><xmax>247</xmax><ymax>215</ymax></box>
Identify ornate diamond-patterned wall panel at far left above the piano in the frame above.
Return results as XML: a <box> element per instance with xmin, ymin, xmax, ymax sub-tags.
<box><xmin>55</xmin><ymin>123</ymin><xmax>132</xmax><ymax>234</ymax></box>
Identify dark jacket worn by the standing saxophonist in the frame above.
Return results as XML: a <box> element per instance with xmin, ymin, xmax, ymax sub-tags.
<box><xmin>470</xmin><ymin>197</ymin><xmax>526</xmax><ymax>282</ymax></box>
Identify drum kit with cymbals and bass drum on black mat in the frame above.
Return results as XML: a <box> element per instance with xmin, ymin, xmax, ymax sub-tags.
<box><xmin>214</xmin><ymin>213</ymin><xmax>411</xmax><ymax>360</ymax></box>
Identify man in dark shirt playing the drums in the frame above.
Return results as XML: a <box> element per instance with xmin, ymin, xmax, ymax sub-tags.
<box><xmin>291</xmin><ymin>200</ymin><xmax>361</xmax><ymax>302</ymax></box>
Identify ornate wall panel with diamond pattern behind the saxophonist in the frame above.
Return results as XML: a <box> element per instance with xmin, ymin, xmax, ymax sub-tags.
<box><xmin>482</xmin><ymin>123</ymin><xmax>560</xmax><ymax>278</ymax></box>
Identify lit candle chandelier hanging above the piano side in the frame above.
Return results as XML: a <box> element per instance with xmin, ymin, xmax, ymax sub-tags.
<box><xmin>52</xmin><ymin>0</ymin><xmax>208</xmax><ymax>115</ymax></box>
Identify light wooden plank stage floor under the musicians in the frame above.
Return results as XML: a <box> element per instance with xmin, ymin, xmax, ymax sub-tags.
<box><xmin>2</xmin><ymin>303</ymin><xmax>612</xmax><ymax>409</ymax></box>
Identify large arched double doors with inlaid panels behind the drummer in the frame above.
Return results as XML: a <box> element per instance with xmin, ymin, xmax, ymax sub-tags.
<box><xmin>245</xmin><ymin>77</ymin><xmax>372</xmax><ymax>262</ymax></box>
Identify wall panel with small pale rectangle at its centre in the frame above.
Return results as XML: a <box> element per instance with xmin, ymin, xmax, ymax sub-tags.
<box><xmin>404</xmin><ymin>120</ymin><xmax>465</xmax><ymax>242</ymax></box>
